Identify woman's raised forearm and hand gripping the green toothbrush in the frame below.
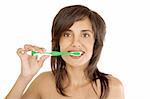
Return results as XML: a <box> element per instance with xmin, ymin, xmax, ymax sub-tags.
<box><xmin>6</xmin><ymin>44</ymin><xmax>48</xmax><ymax>99</ymax></box>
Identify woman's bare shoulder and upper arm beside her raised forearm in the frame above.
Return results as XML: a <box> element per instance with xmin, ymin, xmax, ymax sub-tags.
<box><xmin>23</xmin><ymin>72</ymin><xmax>54</xmax><ymax>99</ymax></box>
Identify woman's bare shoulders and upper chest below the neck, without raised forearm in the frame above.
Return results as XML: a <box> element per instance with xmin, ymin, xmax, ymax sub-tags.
<box><xmin>22</xmin><ymin>72</ymin><xmax>124</xmax><ymax>99</ymax></box>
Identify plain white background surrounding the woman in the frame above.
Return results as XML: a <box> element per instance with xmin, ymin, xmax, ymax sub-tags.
<box><xmin>0</xmin><ymin>0</ymin><xmax>150</xmax><ymax>99</ymax></box>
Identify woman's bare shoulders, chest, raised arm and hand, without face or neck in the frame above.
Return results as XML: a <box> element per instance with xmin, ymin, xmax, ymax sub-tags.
<box><xmin>5</xmin><ymin>45</ymin><xmax>124</xmax><ymax>99</ymax></box>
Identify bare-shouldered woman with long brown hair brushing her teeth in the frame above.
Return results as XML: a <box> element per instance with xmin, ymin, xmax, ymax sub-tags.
<box><xmin>6</xmin><ymin>5</ymin><xmax>124</xmax><ymax>99</ymax></box>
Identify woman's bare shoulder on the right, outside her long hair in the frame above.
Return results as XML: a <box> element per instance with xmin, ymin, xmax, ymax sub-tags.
<box><xmin>108</xmin><ymin>75</ymin><xmax>124</xmax><ymax>99</ymax></box>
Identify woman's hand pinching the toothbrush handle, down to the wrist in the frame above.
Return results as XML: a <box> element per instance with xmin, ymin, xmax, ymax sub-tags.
<box><xmin>17</xmin><ymin>44</ymin><xmax>49</xmax><ymax>78</ymax></box>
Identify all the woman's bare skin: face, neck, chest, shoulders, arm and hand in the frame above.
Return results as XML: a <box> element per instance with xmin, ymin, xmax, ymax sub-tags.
<box><xmin>5</xmin><ymin>18</ymin><xmax>124</xmax><ymax>99</ymax></box>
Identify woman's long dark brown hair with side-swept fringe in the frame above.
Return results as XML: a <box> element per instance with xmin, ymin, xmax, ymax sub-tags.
<box><xmin>51</xmin><ymin>5</ymin><xmax>109</xmax><ymax>99</ymax></box>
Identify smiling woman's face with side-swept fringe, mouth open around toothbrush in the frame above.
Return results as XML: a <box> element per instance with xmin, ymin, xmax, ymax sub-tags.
<box><xmin>59</xmin><ymin>18</ymin><xmax>94</xmax><ymax>67</ymax></box>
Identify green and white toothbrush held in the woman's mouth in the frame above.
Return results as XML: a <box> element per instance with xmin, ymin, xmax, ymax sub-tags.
<box><xmin>31</xmin><ymin>51</ymin><xmax>81</xmax><ymax>56</ymax></box>
